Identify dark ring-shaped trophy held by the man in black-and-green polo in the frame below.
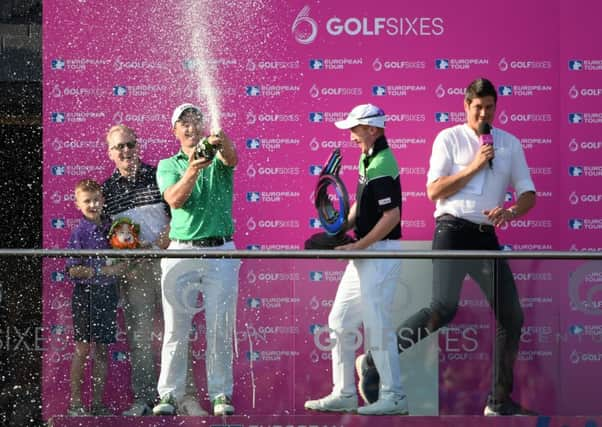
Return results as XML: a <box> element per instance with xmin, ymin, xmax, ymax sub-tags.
<box><xmin>304</xmin><ymin>148</ymin><xmax>354</xmax><ymax>249</ymax></box>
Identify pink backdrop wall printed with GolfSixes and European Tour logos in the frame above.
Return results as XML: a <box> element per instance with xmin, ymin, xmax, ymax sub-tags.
<box><xmin>43</xmin><ymin>0</ymin><xmax>602</xmax><ymax>417</ymax></box>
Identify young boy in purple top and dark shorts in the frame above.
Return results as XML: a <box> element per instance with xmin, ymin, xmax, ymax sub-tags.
<box><xmin>66</xmin><ymin>179</ymin><xmax>125</xmax><ymax>416</ymax></box>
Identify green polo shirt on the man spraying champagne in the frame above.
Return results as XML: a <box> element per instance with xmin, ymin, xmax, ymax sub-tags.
<box><xmin>157</xmin><ymin>150</ymin><xmax>234</xmax><ymax>240</ymax></box>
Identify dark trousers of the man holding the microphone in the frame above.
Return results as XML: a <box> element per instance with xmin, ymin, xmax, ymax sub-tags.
<box><xmin>397</xmin><ymin>215</ymin><xmax>523</xmax><ymax>405</ymax></box>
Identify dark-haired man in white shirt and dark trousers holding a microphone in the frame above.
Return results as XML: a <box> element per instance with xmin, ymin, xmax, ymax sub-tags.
<box><xmin>356</xmin><ymin>78</ymin><xmax>535</xmax><ymax>415</ymax></box>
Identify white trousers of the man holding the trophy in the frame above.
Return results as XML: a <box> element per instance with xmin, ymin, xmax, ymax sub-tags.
<box><xmin>328</xmin><ymin>240</ymin><xmax>405</xmax><ymax>399</ymax></box>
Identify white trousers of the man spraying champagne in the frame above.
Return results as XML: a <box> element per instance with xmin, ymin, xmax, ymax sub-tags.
<box><xmin>157</xmin><ymin>242</ymin><xmax>240</xmax><ymax>400</ymax></box>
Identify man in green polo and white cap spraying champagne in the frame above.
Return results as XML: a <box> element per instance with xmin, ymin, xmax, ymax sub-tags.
<box><xmin>153</xmin><ymin>104</ymin><xmax>240</xmax><ymax>415</ymax></box>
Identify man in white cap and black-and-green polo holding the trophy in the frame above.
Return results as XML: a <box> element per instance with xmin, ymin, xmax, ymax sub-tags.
<box><xmin>305</xmin><ymin>104</ymin><xmax>408</xmax><ymax>415</ymax></box>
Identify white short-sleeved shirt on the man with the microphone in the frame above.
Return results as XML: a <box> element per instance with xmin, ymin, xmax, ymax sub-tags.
<box><xmin>427</xmin><ymin>123</ymin><xmax>535</xmax><ymax>224</ymax></box>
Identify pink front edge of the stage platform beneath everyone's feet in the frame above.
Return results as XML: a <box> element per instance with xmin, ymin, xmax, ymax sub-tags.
<box><xmin>49</xmin><ymin>414</ymin><xmax>602</xmax><ymax>427</ymax></box>
